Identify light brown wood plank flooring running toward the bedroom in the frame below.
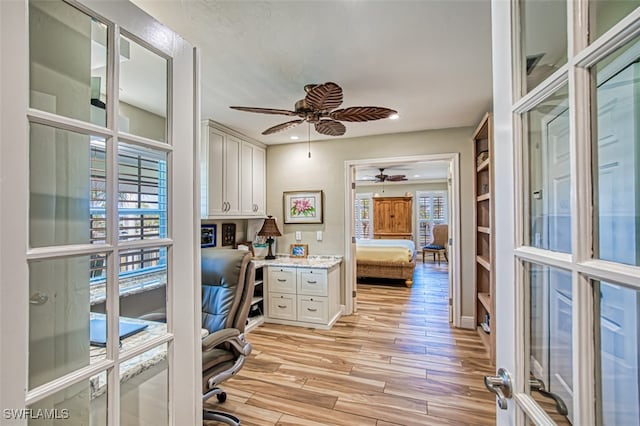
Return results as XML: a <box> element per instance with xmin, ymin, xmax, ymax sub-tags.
<box><xmin>205</xmin><ymin>262</ymin><xmax>496</xmax><ymax>426</ymax></box>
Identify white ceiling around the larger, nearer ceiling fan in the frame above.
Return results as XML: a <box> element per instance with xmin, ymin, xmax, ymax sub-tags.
<box><xmin>133</xmin><ymin>0</ymin><xmax>492</xmax><ymax>145</ymax></box>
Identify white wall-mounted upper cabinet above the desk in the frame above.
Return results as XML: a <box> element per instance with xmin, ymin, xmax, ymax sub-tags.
<box><xmin>201</xmin><ymin>121</ymin><xmax>266</xmax><ymax>218</ymax></box>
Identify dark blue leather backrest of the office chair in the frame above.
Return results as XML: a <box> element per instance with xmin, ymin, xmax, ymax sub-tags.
<box><xmin>201</xmin><ymin>248</ymin><xmax>255</xmax><ymax>333</ymax></box>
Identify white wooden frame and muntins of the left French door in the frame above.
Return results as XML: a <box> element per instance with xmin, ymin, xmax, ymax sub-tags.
<box><xmin>0</xmin><ymin>0</ymin><xmax>202</xmax><ymax>425</ymax></box>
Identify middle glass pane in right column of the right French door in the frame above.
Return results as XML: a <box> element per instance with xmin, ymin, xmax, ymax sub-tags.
<box><xmin>593</xmin><ymin>34</ymin><xmax>640</xmax><ymax>265</ymax></box>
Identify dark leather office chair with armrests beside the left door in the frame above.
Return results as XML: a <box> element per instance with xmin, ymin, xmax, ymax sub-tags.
<box><xmin>201</xmin><ymin>248</ymin><xmax>255</xmax><ymax>426</ymax></box>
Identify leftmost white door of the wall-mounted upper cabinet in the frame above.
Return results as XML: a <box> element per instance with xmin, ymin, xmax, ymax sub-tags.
<box><xmin>208</xmin><ymin>129</ymin><xmax>226</xmax><ymax>216</ymax></box>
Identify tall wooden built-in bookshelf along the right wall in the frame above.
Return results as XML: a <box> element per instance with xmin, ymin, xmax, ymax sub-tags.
<box><xmin>473</xmin><ymin>113</ymin><xmax>496</xmax><ymax>363</ymax></box>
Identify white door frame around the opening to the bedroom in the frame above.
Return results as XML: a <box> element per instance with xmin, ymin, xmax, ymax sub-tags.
<box><xmin>344</xmin><ymin>152</ymin><xmax>462</xmax><ymax>327</ymax></box>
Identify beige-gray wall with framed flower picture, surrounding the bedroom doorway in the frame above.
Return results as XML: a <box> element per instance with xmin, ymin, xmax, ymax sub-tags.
<box><xmin>267</xmin><ymin>127</ymin><xmax>475</xmax><ymax>316</ymax></box>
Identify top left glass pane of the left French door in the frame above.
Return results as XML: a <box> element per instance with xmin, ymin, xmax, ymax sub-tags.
<box><xmin>29</xmin><ymin>0</ymin><xmax>108</xmax><ymax>126</ymax></box>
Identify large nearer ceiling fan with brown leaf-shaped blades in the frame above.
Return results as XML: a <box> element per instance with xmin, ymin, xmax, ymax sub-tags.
<box><xmin>230</xmin><ymin>82</ymin><xmax>397</xmax><ymax>136</ymax></box>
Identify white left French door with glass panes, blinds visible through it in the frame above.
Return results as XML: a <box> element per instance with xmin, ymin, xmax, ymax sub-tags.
<box><xmin>0</xmin><ymin>0</ymin><xmax>201</xmax><ymax>426</ymax></box>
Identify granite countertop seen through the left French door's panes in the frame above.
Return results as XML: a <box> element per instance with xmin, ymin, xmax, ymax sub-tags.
<box><xmin>90</xmin><ymin>312</ymin><xmax>167</xmax><ymax>399</ymax></box>
